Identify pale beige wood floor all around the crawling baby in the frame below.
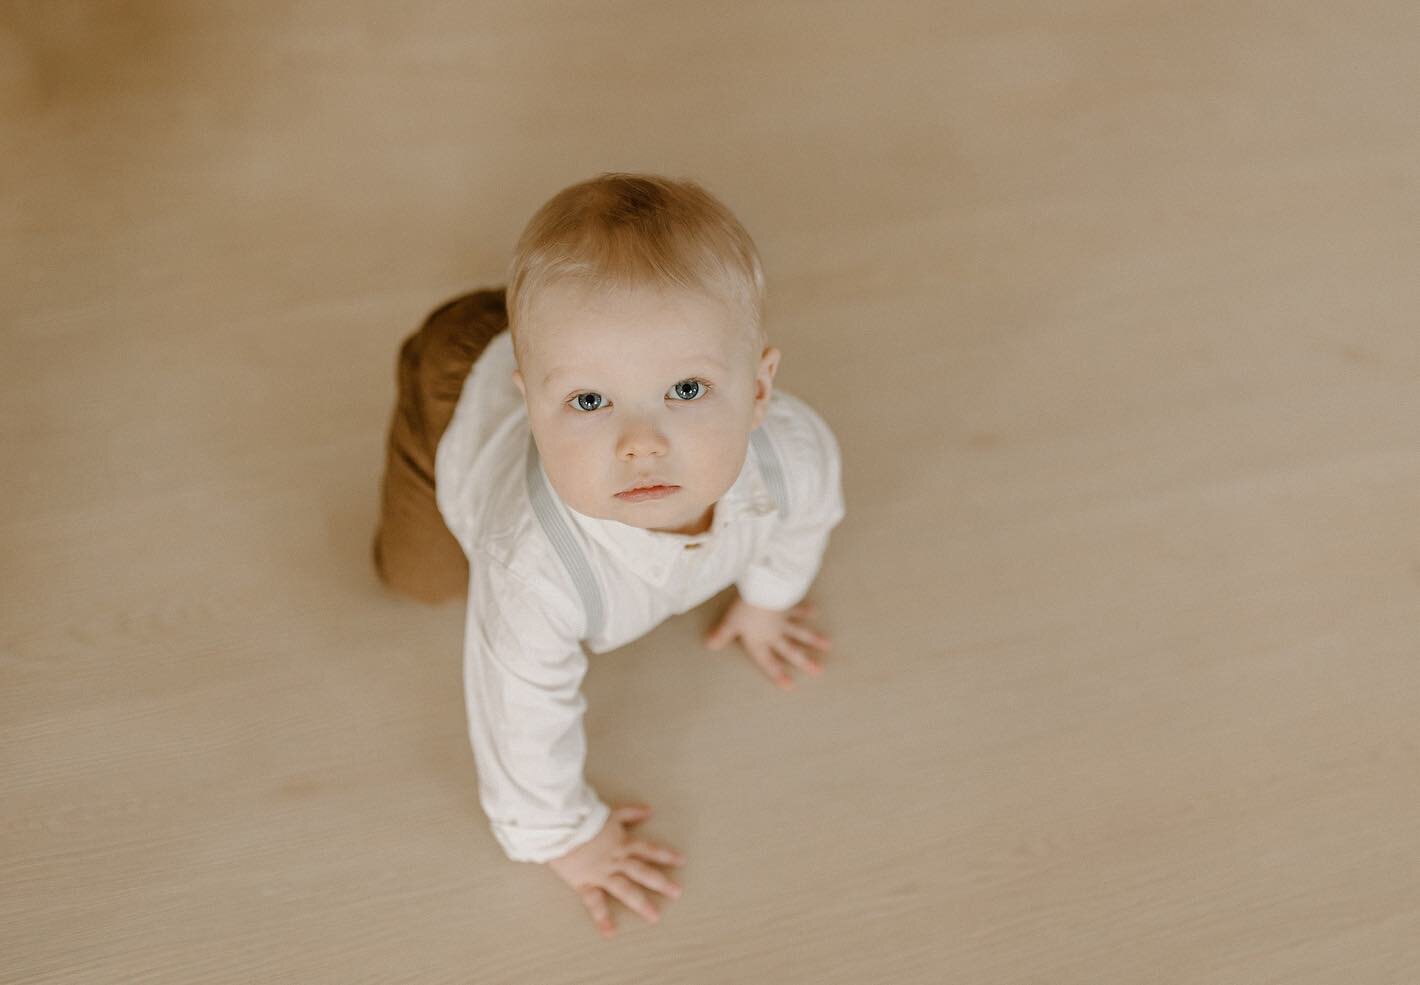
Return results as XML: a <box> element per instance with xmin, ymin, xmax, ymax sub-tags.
<box><xmin>0</xmin><ymin>0</ymin><xmax>1420</xmax><ymax>985</ymax></box>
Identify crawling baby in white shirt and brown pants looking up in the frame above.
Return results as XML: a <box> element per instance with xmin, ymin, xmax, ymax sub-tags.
<box><xmin>375</xmin><ymin>173</ymin><xmax>843</xmax><ymax>937</ymax></box>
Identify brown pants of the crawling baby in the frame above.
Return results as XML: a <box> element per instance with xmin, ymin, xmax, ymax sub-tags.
<box><xmin>373</xmin><ymin>287</ymin><xmax>508</xmax><ymax>602</ymax></box>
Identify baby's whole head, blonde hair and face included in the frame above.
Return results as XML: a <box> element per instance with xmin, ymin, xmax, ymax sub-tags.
<box><xmin>507</xmin><ymin>173</ymin><xmax>780</xmax><ymax>534</ymax></box>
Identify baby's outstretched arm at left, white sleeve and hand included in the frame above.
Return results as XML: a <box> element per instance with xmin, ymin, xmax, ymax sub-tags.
<box><xmin>464</xmin><ymin>555</ymin><xmax>683</xmax><ymax>937</ymax></box>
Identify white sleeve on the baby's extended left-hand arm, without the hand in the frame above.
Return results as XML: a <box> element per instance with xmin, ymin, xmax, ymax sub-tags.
<box><xmin>463</xmin><ymin>552</ymin><xmax>611</xmax><ymax>862</ymax></box>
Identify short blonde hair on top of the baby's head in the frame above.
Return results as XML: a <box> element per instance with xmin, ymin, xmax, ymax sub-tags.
<box><xmin>507</xmin><ymin>172</ymin><xmax>765</xmax><ymax>363</ymax></box>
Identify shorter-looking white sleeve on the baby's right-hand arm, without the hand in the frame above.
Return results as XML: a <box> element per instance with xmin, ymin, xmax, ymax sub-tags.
<box><xmin>736</xmin><ymin>399</ymin><xmax>845</xmax><ymax>610</ymax></box>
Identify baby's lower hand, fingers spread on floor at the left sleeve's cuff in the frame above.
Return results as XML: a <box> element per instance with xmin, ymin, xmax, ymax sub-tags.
<box><xmin>547</xmin><ymin>805</ymin><xmax>686</xmax><ymax>937</ymax></box>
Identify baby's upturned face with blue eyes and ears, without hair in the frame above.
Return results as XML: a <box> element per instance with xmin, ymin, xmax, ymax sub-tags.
<box><xmin>513</xmin><ymin>285</ymin><xmax>780</xmax><ymax>534</ymax></box>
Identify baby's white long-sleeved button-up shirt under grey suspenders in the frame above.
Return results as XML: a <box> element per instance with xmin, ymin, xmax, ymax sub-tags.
<box><xmin>435</xmin><ymin>331</ymin><xmax>843</xmax><ymax>862</ymax></box>
